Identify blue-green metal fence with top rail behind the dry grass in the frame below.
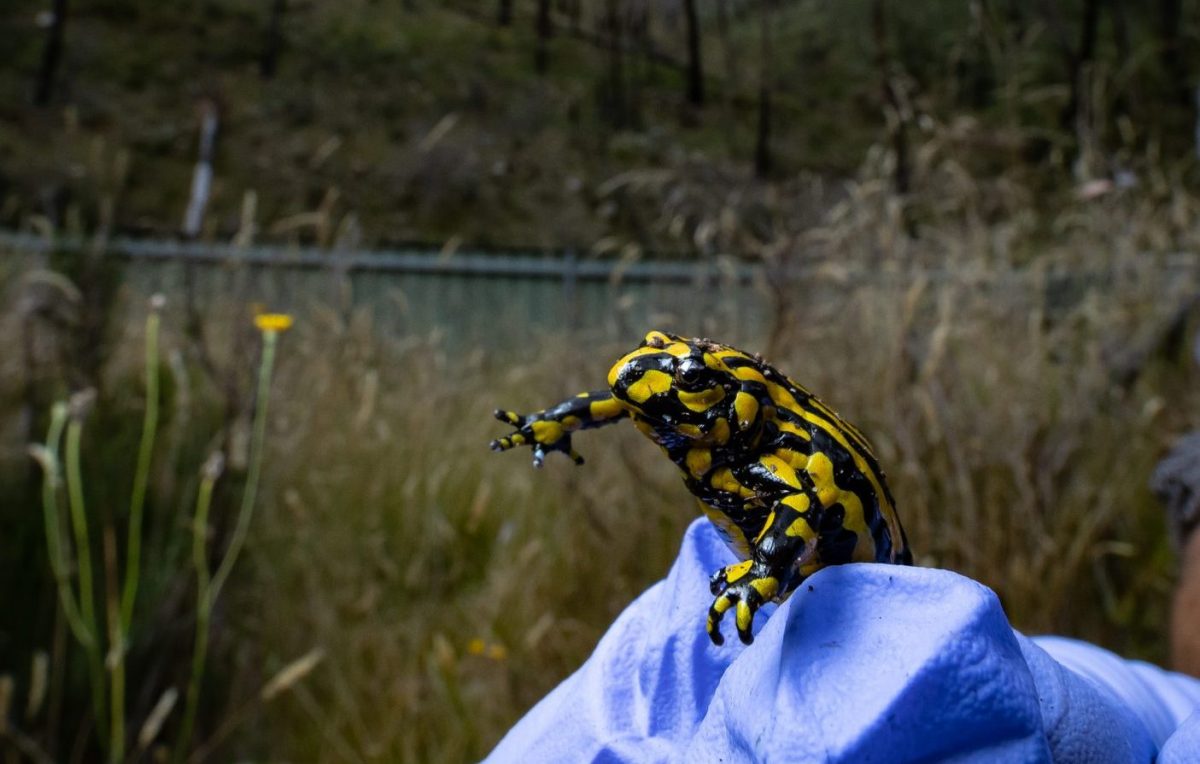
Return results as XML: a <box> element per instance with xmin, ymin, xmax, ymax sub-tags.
<box><xmin>0</xmin><ymin>230</ymin><xmax>766</xmax><ymax>347</ymax></box>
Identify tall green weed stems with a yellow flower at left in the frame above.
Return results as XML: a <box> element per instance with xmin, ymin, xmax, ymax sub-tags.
<box><xmin>13</xmin><ymin>295</ymin><xmax>302</xmax><ymax>762</ymax></box>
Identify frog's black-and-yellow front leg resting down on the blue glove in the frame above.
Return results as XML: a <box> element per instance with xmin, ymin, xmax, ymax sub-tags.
<box><xmin>707</xmin><ymin>492</ymin><xmax>820</xmax><ymax>645</ymax></box>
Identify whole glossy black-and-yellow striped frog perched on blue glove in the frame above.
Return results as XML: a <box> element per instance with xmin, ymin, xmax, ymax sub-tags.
<box><xmin>491</xmin><ymin>330</ymin><xmax>913</xmax><ymax>646</ymax></box>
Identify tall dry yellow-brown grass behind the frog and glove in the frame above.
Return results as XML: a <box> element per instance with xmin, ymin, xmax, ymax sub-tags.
<box><xmin>229</xmin><ymin>196</ymin><xmax>1200</xmax><ymax>760</ymax></box>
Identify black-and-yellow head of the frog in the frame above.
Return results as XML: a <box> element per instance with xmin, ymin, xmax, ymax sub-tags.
<box><xmin>608</xmin><ymin>331</ymin><xmax>740</xmax><ymax>445</ymax></box>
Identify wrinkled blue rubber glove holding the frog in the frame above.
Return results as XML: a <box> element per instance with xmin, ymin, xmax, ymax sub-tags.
<box><xmin>487</xmin><ymin>521</ymin><xmax>1200</xmax><ymax>764</ymax></box>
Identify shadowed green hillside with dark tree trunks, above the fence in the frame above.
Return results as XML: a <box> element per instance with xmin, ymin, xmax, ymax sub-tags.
<box><xmin>0</xmin><ymin>0</ymin><xmax>1200</xmax><ymax>247</ymax></box>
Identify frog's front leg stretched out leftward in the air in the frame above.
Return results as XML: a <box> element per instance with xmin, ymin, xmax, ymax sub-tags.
<box><xmin>491</xmin><ymin>390</ymin><xmax>629</xmax><ymax>467</ymax></box>
